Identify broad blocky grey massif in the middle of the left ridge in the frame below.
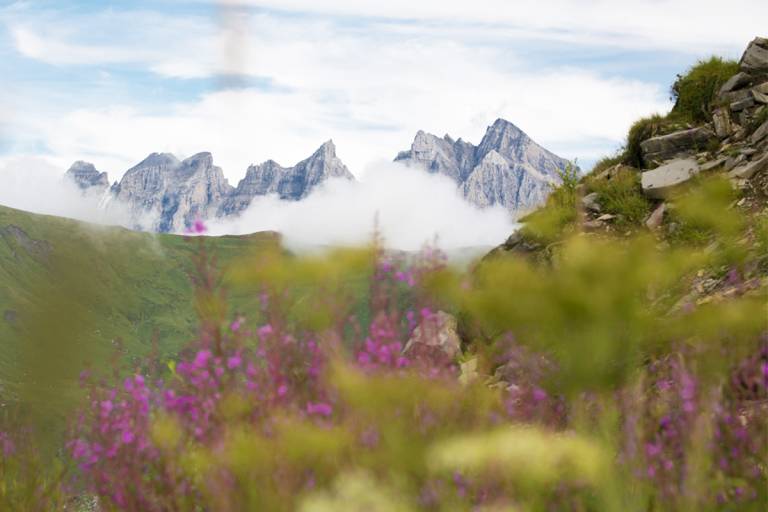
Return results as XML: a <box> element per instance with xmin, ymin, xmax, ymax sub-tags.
<box><xmin>112</xmin><ymin>153</ymin><xmax>233</xmax><ymax>232</ymax></box>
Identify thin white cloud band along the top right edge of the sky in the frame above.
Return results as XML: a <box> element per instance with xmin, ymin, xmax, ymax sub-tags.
<box><xmin>220</xmin><ymin>0</ymin><xmax>768</xmax><ymax>54</ymax></box>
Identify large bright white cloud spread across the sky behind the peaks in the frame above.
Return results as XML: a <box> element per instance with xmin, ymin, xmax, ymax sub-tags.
<box><xmin>9</xmin><ymin>7</ymin><xmax>669</xmax><ymax>182</ymax></box>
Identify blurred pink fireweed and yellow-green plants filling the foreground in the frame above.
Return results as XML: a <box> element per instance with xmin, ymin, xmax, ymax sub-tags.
<box><xmin>0</xmin><ymin>179</ymin><xmax>768</xmax><ymax>512</ymax></box>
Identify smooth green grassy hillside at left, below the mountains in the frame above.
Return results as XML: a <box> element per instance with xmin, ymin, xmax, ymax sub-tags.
<box><xmin>0</xmin><ymin>206</ymin><xmax>277</xmax><ymax>416</ymax></box>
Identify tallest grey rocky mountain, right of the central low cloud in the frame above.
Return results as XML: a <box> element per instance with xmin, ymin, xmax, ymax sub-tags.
<box><xmin>395</xmin><ymin>119</ymin><xmax>569</xmax><ymax>212</ymax></box>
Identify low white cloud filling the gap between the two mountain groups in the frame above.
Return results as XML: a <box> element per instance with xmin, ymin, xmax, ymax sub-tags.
<box><xmin>209</xmin><ymin>162</ymin><xmax>514</xmax><ymax>252</ymax></box>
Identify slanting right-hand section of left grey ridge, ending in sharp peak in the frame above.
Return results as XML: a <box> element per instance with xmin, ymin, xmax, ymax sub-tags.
<box><xmin>219</xmin><ymin>140</ymin><xmax>354</xmax><ymax>215</ymax></box>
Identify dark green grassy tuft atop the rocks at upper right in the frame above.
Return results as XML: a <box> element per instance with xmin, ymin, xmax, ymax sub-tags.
<box><xmin>672</xmin><ymin>57</ymin><xmax>739</xmax><ymax>123</ymax></box>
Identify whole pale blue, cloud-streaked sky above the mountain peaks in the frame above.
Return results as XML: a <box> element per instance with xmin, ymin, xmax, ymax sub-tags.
<box><xmin>0</xmin><ymin>0</ymin><xmax>768</xmax><ymax>181</ymax></box>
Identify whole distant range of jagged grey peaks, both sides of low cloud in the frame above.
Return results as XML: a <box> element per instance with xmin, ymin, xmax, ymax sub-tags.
<box><xmin>66</xmin><ymin>119</ymin><xmax>568</xmax><ymax>233</ymax></box>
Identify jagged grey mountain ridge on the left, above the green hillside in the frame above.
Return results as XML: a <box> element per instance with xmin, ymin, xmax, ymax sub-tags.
<box><xmin>65</xmin><ymin>140</ymin><xmax>354</xmax><ymax>233</ymax></box>
